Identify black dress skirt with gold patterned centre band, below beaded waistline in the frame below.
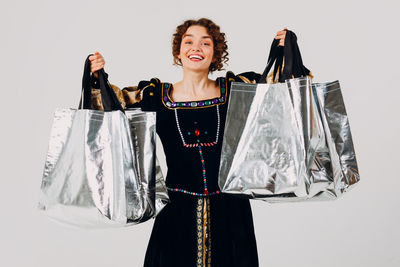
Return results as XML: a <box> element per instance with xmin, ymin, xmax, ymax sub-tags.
<box><xmin>144</xmin><ymin>192</ymin><xmax>258</xmax><ymax>267</ymax></box>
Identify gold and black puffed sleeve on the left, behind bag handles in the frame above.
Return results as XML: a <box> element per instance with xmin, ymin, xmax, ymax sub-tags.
<box><xmin>91</xmin><ymin>72</ymin><xmax>160</xmax><ymax>111</ymax></box>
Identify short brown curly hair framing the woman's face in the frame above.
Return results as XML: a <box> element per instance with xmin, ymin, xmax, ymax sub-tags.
<box><xmin>172</xmin><ymin>18</ymin><xmax>229</xmax><ymax>72</ymax></box>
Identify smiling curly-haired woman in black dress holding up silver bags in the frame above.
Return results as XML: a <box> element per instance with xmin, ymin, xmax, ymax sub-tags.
<box><xmin>90</xmin><ymin>18</ymin><xmax>285</xmax><ymax>267</ymax></box>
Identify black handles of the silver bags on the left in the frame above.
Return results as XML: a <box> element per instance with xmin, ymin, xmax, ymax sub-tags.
<box><xmin>79</xmin><ymin>54</ymin><xmax>125</xmax><ymax>113</ymax></box>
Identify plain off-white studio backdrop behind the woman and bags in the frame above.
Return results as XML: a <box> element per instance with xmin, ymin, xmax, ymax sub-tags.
<box><xmin>0</xmin><ymin>0</ymin><xmax>400</xmax><ymax>267</ymax></box>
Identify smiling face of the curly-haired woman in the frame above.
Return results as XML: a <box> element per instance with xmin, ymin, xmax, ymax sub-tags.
<box><xmin>178</xmin><ymin>25</ymin><xmax>214</xmax><ymax>72</ymax></box>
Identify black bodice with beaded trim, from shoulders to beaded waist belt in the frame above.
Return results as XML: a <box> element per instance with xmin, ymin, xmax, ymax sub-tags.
<box><xmin>123</xmin><ymin>72</ymin><xmax>259</xmax><ymax>196</ymax></box>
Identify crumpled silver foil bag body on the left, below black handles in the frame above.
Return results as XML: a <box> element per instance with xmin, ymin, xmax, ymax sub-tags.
<box><xmin>38</xmin><ymin>109</ymin><xmax>169</xmax><ymax>228</ymax></box>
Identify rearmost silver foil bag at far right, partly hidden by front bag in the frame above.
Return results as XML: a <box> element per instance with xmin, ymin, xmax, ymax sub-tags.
<box><xmin>310</xmin><ymin>81</ymin><xmax>360</xmax><ymax>200</ymax></box>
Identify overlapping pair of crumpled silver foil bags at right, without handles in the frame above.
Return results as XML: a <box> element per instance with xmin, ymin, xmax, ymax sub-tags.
<box><xmin>218</xmin><ymin>77</ymin><xmax>359</xmax><ymax>203</ymax></box>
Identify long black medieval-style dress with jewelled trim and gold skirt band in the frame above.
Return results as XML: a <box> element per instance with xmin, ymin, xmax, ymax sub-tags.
<box><xmin>128</xmin><ymin>72</ymin><xmax>259</xmax><ymax>267</ymax></box>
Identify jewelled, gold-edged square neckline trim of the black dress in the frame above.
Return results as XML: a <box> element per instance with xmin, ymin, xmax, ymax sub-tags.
<box><xmin>161</xmin><ymin>77</ymin><xmax>228</xmax><ymax>109</ymax></box>
